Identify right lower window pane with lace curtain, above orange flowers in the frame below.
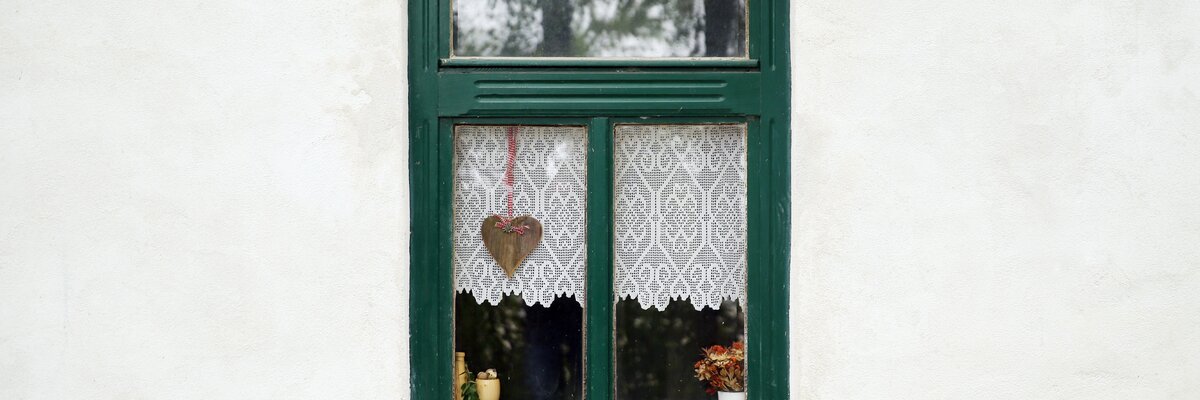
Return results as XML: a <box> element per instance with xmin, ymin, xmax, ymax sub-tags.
<box><xmin>614</xmin><ymin>124</ymin><xmax>746</xmax><ymax>399</ymax></box>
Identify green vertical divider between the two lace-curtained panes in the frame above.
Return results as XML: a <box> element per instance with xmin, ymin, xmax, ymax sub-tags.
<box><xmin>583</xmin><ymin>117</ymin><xmax>616</xmax><ymax>400</ymax></box>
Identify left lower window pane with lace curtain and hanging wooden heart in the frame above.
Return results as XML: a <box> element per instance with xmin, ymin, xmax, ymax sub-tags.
<box><xmin>452</xmin><ymin>125</ymin><xmax>587</xmax><ymax>399</ymax></box>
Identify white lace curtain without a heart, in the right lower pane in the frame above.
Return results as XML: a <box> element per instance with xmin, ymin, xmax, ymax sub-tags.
<box><xmin>613</xmin><ymin>125</ymin><xmax>746</xmax><ymax>310</ymax></box>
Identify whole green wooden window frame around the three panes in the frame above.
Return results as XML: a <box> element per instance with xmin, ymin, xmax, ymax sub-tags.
<box><xmin>408</xmin><ymin>0</ymin><xmax>791</xmax><ymax>400</ymax></box>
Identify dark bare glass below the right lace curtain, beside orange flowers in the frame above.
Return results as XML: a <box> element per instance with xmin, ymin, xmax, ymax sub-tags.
<box><xmin>614</xmin><ymin>299</ymin><xmax>745</xmax><ymax>400</ymax></box>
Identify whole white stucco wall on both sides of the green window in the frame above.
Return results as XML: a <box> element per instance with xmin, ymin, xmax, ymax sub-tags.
<box><xmin>0</xmin><ymin>0</ymin><xmax>1200</xmax><ymax>400</ymax></box>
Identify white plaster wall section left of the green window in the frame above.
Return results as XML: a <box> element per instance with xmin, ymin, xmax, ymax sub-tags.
<box><xmin>0</xmin><ymin>0</ymin><xmax>408</xmax><ymax>400</ymax></box>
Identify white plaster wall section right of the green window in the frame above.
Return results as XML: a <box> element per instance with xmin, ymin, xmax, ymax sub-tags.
<box><xmin>791</xmin><ymin>0</ymin><xmax>1200</xmax><ymax>400</ymax></box>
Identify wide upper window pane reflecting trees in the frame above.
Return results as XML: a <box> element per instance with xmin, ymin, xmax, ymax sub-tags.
<box><xmin>451</xmin><ymin>0</ymin><xmax>746</xmax><ymax>58</ymax></box>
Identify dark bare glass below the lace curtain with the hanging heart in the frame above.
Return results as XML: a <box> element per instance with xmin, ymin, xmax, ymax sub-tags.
<box><xmin>455</xmin><ymin>289</ymin><xmax>583</xmax><ymax>400</ymax></box>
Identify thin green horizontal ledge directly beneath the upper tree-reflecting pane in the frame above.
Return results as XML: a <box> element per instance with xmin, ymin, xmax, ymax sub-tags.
<box><xmin>439</xmin><ymin>56</ymin><xmax>758</xmax><ymax>68</ymax></box>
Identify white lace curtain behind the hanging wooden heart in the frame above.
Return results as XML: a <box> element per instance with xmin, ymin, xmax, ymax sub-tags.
<box><xmin>452</xmin><ymin>125</ymin><xmax>587</xmax><ymax>306</ymax></box>
